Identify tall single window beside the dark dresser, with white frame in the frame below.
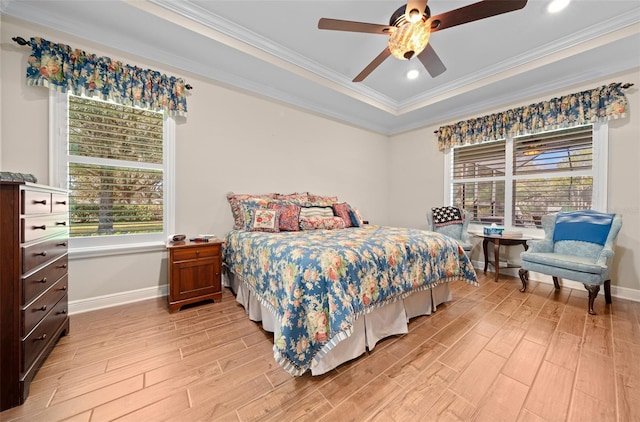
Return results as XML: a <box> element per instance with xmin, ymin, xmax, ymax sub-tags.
<box><xmin>52</xmin><ymin>94</ymin><xmax>173</xmax><ymax>254</ymax></box>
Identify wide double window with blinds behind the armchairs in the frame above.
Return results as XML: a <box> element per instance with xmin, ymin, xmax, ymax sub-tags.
<box><xmin>447</xmin><ymin>125</ymin><xmax>607</xmax><ymax>229</ymax></box>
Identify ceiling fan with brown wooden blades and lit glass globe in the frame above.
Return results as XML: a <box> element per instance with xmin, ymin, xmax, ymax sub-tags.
<box><xmin>318</xmin><ymin>0</ymin><xmax>527</xmax><ymax>82</ymax></box>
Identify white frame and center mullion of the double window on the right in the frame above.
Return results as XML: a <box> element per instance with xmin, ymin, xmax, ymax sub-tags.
<box><xmin>443</xmin><ymin>122</ymin><xmax>609</xmax><ymax>237</ymax></box>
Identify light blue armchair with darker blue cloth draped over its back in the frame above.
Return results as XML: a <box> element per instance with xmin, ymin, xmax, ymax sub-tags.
<box><xmin>519</xmin><ymin>210</ymin><xmax>622</xmax><ymax>315</ymax></box>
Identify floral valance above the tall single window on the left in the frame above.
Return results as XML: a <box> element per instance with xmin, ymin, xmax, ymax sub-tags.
<box><xmin>27</xmin><ymin>37</ymin><xmax>187</xmax><ymax>116</ymax></box>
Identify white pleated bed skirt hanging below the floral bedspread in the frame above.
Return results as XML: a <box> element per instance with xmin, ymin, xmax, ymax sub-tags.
<box><xmin>223</xmin><ymin>271</ymin><xmax>451</xmax><ymax>375</ymax></box>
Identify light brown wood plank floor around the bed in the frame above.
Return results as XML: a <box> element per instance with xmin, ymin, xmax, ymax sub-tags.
<box><xmin>0</xmin><ymin>274</ymin><xmax>640</xmax><ymax>422</ymax></box>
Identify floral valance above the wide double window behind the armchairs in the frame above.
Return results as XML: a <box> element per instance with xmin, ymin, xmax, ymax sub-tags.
<box><xmin>436</xmin><ymin>83</ymin><xmax>627</xmax><ymax>151</ymax></box>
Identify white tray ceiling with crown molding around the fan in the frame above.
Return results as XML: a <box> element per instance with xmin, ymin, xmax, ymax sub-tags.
<box><xmin>0</xmin><ymin>0</ymin><xmax>640</xmax><ymax>135</ymax></box>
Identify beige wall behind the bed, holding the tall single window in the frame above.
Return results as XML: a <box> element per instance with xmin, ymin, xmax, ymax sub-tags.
<box><xmin>0</xmin><ymin>16</ymin><xmax>389</xmax><ymax>306</ymax></box>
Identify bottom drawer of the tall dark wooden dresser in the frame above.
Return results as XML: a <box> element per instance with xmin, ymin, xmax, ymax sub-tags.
<box><xmin>22</xmin><ymin>295</ymin><xmax>67</xmax><ymax>372</ymax></box>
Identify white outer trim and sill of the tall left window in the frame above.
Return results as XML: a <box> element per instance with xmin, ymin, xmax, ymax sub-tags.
<box><xmin>49</xmin><ymin>91</ymin><xmax>175</xmax><ymax>258</ymax></box>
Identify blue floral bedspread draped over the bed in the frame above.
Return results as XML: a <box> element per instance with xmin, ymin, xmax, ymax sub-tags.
<box><xmin>223</xmin><ymin>225</ymin><xmax>477</xmax><ymax>375</ymax></box>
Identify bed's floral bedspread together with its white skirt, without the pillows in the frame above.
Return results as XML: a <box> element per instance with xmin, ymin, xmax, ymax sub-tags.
<box><xmin>223</xmin><ymin>224</ymin><xmax>477</xmax><ymax>376</ymax></box>
